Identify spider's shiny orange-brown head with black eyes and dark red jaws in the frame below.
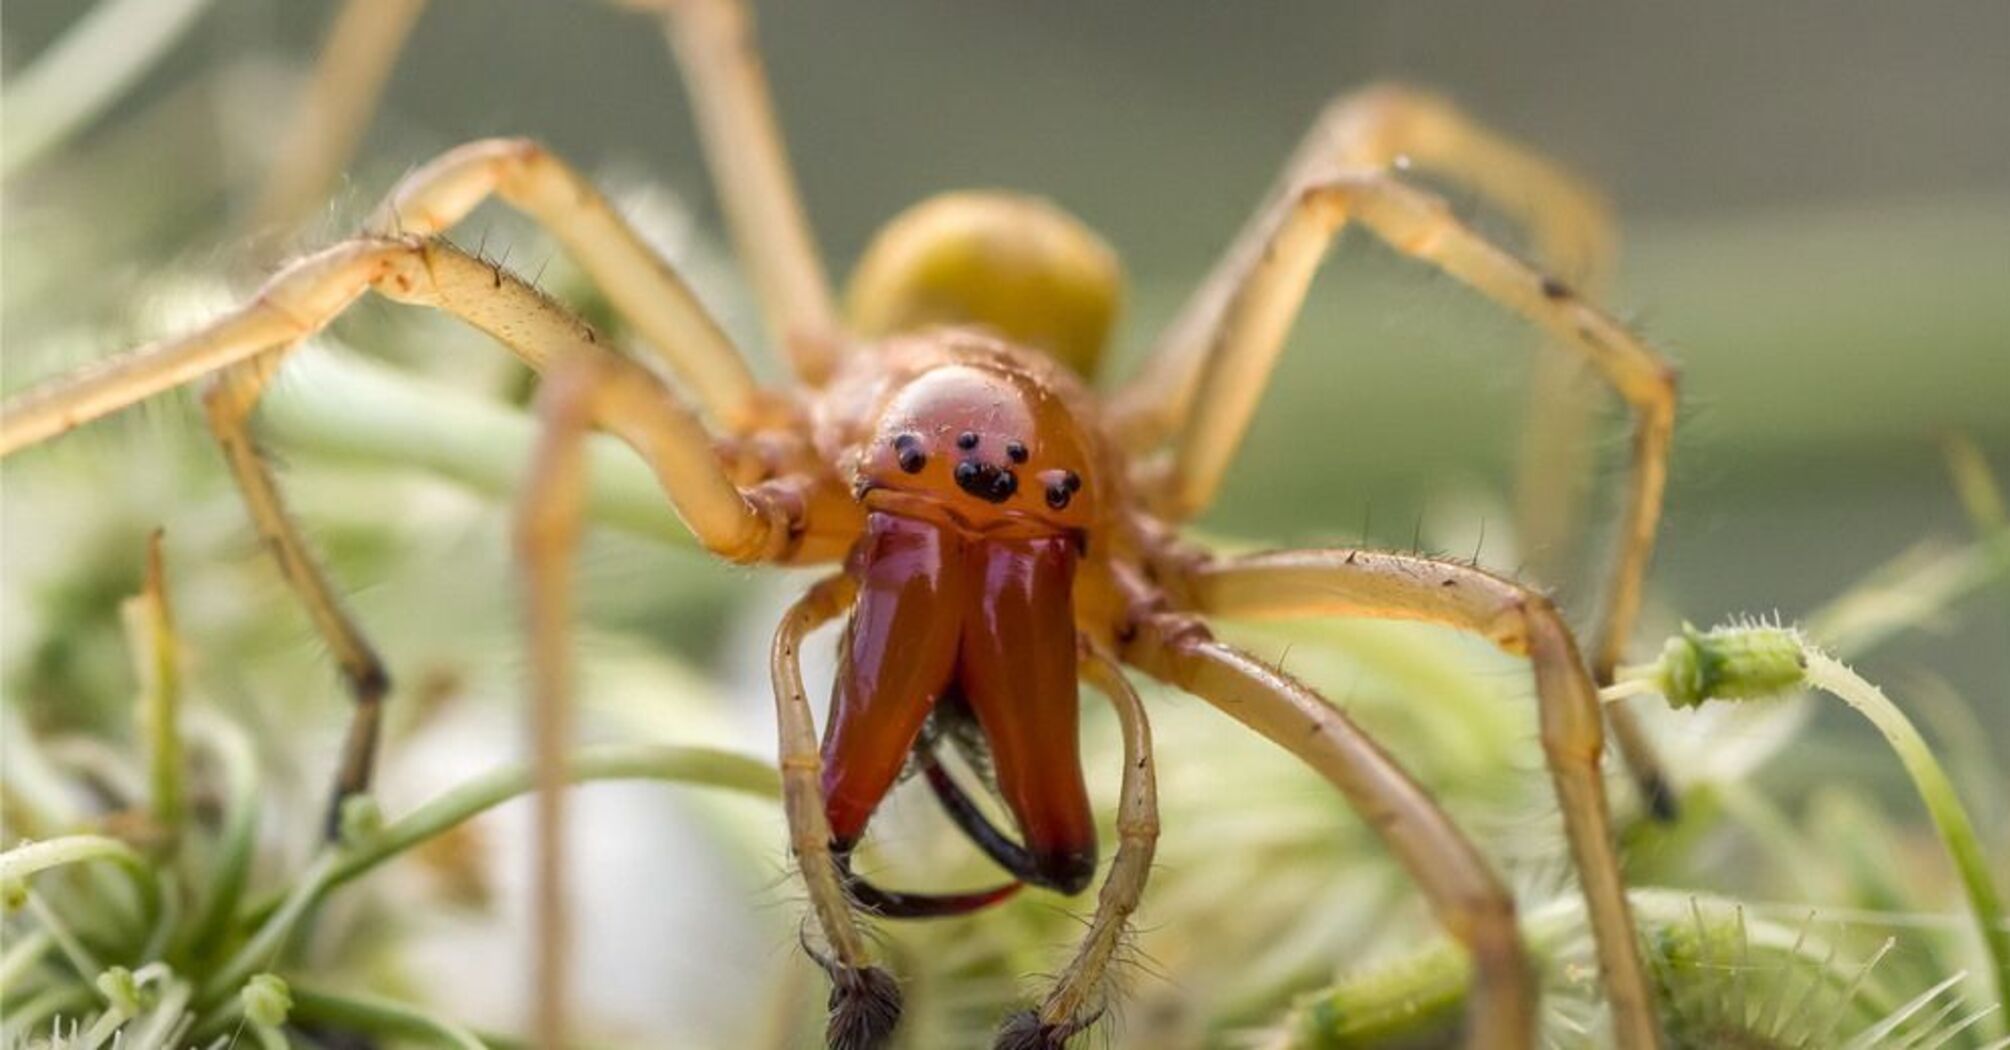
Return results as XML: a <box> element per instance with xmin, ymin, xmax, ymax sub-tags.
<box><xmin>822</xmin><ymin>330</ymin><xmax>1103</xmax><ymax>893</ymax></box>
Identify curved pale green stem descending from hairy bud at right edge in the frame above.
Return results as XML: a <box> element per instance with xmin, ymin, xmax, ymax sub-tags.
<box><xmin>1807</xmin><ymin>646</ymin><xmax>2010</xmax><ymax>1010</ymax></box>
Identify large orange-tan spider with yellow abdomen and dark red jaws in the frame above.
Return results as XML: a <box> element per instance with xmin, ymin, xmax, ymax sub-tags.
<box><xmin>0</xmin><ymin>0</ymin><xmax>1674</xmax><ymax>1048</ymax></box>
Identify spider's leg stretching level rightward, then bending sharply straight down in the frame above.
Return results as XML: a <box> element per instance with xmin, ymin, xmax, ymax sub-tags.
<box><xmin>1178</xmin><ymin>549</ymin><xmax>1658</xmax><ymax>1048</ymax></box>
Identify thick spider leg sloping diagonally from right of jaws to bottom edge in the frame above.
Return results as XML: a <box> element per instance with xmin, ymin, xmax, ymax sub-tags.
<box><xmin>1122</xmin><ymin>599</ymin><xmax>1536</xmax><ymax>1050</ymax></box>
